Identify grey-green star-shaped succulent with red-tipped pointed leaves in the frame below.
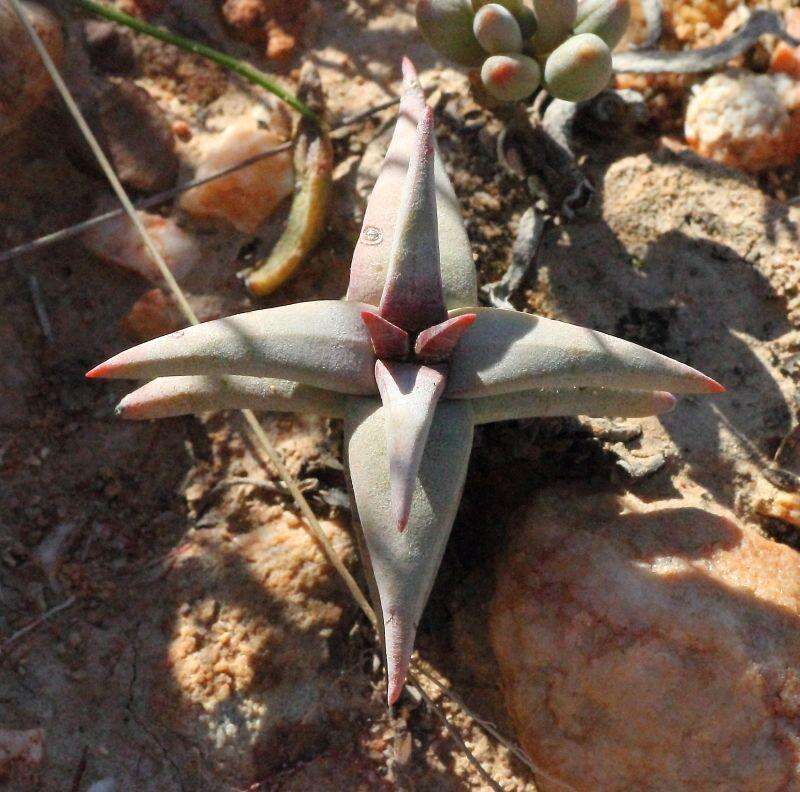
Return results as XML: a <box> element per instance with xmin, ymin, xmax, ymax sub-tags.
<box><xmin>87</xmin><ymin>59</ymin><xmax>723</xmax><ymax>703</ymax></box>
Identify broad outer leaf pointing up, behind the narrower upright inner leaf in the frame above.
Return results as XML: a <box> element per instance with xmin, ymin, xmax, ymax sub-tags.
<box><xmin>347</xmin><ymin>58</ymin><xmax>478</xmax><ymax>310</ymax></box>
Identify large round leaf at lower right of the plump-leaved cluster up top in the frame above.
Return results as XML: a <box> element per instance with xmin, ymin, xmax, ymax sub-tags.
<box><xmin>544</xmin><ymin>33</ymin><xmax>611</xmax><ymax>102</ymax></box>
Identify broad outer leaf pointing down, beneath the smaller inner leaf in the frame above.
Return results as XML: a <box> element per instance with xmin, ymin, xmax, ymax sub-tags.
<box><xmin>344</xmin><ymin>399</ymin><xmax>473</xmax><ymax>704</ymax></box>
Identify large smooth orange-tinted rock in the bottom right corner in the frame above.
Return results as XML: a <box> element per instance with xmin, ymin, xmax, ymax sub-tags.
<box><xmin>491</xmin><ymin>489</ymin><xmax>800</xmax><ymax>792</ymax></box>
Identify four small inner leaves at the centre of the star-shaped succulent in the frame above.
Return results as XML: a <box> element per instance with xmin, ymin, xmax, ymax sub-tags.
<box><xmin>361</xmin><ymin>106</ymin><xmax>476</xmax><ymax>531</ymax></box>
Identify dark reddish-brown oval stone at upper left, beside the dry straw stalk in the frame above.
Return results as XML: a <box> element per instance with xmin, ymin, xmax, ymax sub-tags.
<box><xmin>99</xmin><ymin>79</ymin><xmax>178</xmax><ymax>193</ymax></box>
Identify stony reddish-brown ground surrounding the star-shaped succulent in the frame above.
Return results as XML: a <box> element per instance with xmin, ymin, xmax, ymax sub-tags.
<box><xmin>0</xmin><ymin>0</ymin><xmax>800</xmax><ymax>792</ymax></box>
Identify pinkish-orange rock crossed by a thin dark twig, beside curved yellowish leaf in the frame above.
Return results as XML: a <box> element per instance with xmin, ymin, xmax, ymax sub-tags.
<box><xmin>180</xmin><ymin>119</ymin><xmax>294</xmax><ymax>234</ymax></box>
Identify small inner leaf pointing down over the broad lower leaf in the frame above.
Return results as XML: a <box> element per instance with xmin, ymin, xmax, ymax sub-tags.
<box><xmin>375</xmin><ymin>360</ymin><xmax>445</xmax><ymax>531</ymax></box>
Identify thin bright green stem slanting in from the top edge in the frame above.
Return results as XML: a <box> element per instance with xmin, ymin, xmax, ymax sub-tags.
<box><xmin>73</xmin><ymin>0</ymin><xmax>323</xmax><ymax>128</ymax></box>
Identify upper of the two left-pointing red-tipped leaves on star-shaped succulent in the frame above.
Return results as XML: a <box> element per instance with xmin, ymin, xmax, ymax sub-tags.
<box><xmin>87</xmin><ymin>300</ymin><xmax>376</xmax><ymax>395</ymax></box>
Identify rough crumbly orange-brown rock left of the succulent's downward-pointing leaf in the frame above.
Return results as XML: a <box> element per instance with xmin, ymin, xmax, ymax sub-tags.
<box><xmin>159</xmin><ymin>510</ymin><xmax>353</xmax><ymax>785</ymax></box>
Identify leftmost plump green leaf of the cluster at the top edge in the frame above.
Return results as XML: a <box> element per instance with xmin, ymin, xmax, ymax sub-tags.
<box><xmin>416</xmin><ymin>0</ymin><xmax>484</xmax><ymax>66</ymax></box>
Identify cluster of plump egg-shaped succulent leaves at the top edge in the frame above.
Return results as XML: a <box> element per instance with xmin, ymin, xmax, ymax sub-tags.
<box><xmin>417</xmin><ymin>0</ymin><xmax>630</xmax><ymax>102</ymax></box>
